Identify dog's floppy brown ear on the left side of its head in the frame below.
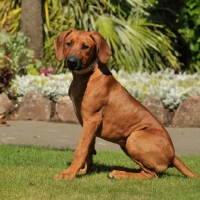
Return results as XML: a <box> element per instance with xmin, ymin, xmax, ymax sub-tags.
<box><xmin>54</xmin><ymin>29</ymin><xmax>73</xmax><ymax>61</ymax></box>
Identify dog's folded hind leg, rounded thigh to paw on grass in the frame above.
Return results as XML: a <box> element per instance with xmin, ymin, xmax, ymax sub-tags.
<box><xmin>108</xmin><ymin>130</ymin><xmax>174</xmax><ymax>179</ymax></box>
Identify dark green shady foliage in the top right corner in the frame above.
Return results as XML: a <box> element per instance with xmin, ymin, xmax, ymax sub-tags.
<box><xmin>145</xmin><ymin>0</ymin><xmax>200</xmax><ymax>73</ymax></box>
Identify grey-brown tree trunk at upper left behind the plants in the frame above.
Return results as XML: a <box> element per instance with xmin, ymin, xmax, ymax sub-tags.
<box><xmin>21</xmin><ymin>0</ymin><xmax>43</xmax><ymax>59</ymax></box>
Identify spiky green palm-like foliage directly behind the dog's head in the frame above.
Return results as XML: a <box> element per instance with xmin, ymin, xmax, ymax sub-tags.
<box><xmin>45</xmin><ymin>0</ymin><xmax>180</xmax><ymax>71</ymax></box>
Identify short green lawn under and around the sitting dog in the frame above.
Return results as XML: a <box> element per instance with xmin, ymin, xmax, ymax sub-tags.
<box><xmin>0</xmin><ymin>145</ymin><xmax>200</xmax><ymax>200</ymax></box>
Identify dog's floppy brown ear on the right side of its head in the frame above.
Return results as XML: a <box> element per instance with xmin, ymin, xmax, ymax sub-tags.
<box><xmin>91</xmin><ymin>32</ymin><xmax>112</xmax><ymax>63</ymax></box>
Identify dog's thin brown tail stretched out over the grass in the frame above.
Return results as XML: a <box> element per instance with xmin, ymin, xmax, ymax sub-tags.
<box><xmin>173</xmin><ymin>156</ymin><xmax>200</xmax><ymax>178</ymax></box>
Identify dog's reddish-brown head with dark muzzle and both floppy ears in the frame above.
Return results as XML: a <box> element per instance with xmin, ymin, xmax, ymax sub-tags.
<box><xmin>54</xmin><ymin>29</ymin><xmax>112</xmax><ymax>70</ymax></box>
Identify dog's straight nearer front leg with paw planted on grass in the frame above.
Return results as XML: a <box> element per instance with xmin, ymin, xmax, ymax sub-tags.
<box><xmin>55</xmin><ymin>121</ymin><xmax>100</xmax><ymax>179</ymax></box>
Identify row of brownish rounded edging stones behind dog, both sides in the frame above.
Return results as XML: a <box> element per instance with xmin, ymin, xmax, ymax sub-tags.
<box><xmin>0</xmin><ymin>93</ymin><xmax>200</xmax><ymax>127</ymax></box>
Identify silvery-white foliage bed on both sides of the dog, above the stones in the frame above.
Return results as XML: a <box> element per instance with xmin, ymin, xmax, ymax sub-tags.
<box><xmin>8</xmin><ymin>69</ymin><xmax>200</xmax><ymax>110</ymax></box>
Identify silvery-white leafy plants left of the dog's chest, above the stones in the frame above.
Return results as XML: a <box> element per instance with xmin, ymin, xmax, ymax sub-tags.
<box><xmin>8</xmin><ymin>73</ymin><xmax>72</xmax><ymax>101</ymax></box>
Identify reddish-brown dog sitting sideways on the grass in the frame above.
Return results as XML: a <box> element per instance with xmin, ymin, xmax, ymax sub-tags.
<box><xmin>54</xmin><ymin>29</ymin><xmax>198</xmax><ymax>179</ymax></box>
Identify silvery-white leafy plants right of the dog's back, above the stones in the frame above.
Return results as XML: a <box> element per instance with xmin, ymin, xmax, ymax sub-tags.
<box><xmin>112</xmin><ymin>69</ymin><xmax>200</xmax><ymax>110</ymax></box>
